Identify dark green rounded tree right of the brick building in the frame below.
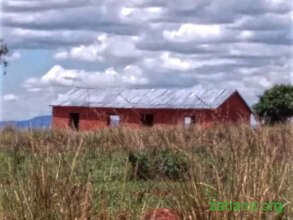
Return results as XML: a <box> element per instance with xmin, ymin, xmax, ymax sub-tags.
<box><xmin>253</xmin><ymin>84</ymin><xmax>293</xmax><ymax>124</ymax></box>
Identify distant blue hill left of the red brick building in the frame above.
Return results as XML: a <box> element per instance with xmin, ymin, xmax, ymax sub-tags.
<box><xmin>0</xmin><ymin>115</ymin><xmax>51</xmax><ymax>129</ymax></box>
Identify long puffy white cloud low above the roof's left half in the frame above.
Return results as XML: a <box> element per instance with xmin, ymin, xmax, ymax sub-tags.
<box><xmin>23</xmin><ymin>65</ymin><xmax>148</xmax><ymax>92</ymax></box>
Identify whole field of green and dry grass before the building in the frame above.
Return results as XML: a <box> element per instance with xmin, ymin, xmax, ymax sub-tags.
<box><xmin>0</xmin><ymin>125</ymin><xmax>293</xmax><ymax>220</ymax></box>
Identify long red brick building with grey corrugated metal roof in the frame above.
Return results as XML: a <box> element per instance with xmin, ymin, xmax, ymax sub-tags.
<box><xmin>52</xmin><ymin>88</ymin><xmax>251</xmax><ymax>131</ymax></box>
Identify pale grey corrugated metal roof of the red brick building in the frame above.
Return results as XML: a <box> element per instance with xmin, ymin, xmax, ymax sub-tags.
<box><xmin>52</xmin><ymin>88</ymin><xmax>236</xmax><ymax>109</ymax></box>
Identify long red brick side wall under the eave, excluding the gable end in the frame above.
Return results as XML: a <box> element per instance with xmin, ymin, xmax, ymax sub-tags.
<box><xmin>52</xmin><ymin>106</ymin><xmax>215</xmax><ymax>130</ymax></box>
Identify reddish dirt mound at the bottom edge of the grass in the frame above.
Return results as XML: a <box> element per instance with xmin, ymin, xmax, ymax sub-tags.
<box><xmin>144</xmin><ymin>208</ymin><xmax>179</xmax><ymax>220</ymax></box>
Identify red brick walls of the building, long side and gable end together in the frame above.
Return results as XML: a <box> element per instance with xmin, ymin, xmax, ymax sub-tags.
<box><xmin>52</xmin><ymin>93</ymin><xmax>250</xmax><ymax>131</ymax></box>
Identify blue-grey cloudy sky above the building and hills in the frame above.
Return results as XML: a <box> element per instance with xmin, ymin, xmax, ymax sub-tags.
<box><xmin>0</xmin><ymin>0</ymin><xmax>293</xmax><ymax>120</ymax></box>
